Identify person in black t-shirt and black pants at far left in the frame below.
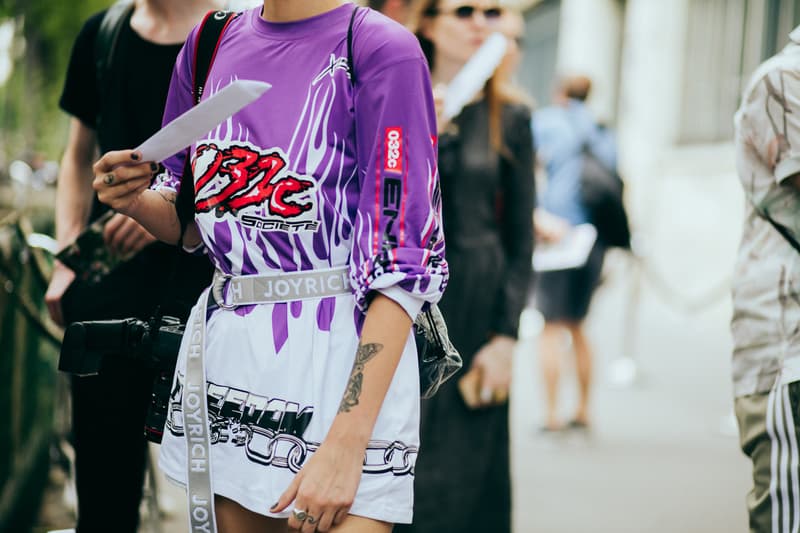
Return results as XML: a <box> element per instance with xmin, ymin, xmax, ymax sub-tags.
<box><xmin>45</xmin><ymin>0</ymin><xmax>222</xmax><ymax>533</ymax></box>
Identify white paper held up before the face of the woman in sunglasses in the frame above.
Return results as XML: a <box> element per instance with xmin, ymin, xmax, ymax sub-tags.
<box><xmin>443</xmin><ymin>32</ymin><xmax>508</xmax><ymax>120</ymax></box>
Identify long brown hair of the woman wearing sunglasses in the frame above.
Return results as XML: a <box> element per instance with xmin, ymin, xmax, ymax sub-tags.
<box><xmin>408</xmin><ymin>0</ymin><xmax>528</xmax><ymax>156</ymax></box>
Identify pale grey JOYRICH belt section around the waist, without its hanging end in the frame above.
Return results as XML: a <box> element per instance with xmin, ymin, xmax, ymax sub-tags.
<box><xmin>211</xmin><ymin>267</ymin><xmax>351</xmax><ymax>309</ymax></box>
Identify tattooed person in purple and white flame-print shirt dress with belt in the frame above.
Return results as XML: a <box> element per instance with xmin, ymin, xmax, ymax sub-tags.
<box><xmin>94</xmin><ymin>0</ymin><xmax>447</xmax><ymax>533</ymax></box>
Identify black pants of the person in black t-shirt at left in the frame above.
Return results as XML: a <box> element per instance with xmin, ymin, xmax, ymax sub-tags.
<box><xmin>62</xmin><ymin>245</ymin><xmax>211</xmax><ymax>533</ymax></box>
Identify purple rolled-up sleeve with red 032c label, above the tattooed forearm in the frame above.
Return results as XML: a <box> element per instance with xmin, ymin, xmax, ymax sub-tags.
<box><xmin>350</xmin><ymin>54</ymin><xmax>447</xmax><ymax>320</ymax></box>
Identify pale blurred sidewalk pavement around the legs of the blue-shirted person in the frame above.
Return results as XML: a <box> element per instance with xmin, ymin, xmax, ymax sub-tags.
<box><xmin>512</xmin><ymin>256</ymin><xmax>750</xmax><ymax>533</ymax></box>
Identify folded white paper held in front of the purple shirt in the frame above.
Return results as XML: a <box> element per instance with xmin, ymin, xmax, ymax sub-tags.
<box><xmin>136</xmin><ymin>80</ymin><xmax>272</xmax><ymax>161</ymax></box>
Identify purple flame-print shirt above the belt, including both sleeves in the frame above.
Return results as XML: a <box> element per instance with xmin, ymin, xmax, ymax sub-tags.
<box><xmin>154</xmin><ymin>4</ymin><xmax>447</xmax><ymax>317</ymax></box>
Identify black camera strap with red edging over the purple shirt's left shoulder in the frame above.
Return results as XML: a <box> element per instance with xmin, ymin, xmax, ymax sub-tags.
<box><xmin>175</xmin><ymin>11</ymin><xmax>239</xmax><ymax>240</ymax></box>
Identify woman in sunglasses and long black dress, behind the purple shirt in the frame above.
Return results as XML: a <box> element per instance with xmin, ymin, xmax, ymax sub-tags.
<box><xmin>397</xmin><ymin>0</ymin><xmax>534</xmax><ymax>533</ymax></box>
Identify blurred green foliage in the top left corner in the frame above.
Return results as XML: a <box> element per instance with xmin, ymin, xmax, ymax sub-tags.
<box><xmin>0</xmin><ymin>0</ymin><xmax>112</xmax><ymax>162</ymax></box>
